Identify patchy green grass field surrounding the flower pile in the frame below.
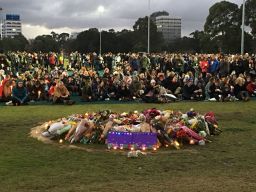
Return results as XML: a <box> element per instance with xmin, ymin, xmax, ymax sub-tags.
<box><xmin>0</xmin><ymin>101</ymin><xmax>256</xmax><ymax>192</ymax></box>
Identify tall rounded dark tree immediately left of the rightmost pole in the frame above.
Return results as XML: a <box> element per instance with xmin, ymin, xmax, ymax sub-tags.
<box><xmin>204</xmin><ymin>1</ymin><xmax>244</xmax><ymax>53</ymax></box>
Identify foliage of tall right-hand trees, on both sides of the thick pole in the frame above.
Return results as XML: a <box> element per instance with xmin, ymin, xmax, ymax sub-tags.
<box><xmin>201</xmin><ymin>0</ymin><xmax>256</xmax><ymax>53</ymax></box>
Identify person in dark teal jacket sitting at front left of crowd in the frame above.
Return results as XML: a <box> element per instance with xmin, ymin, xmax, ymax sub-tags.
<box><xmin>12</xmin><ymin>79</ymin><xmax>29</xmax><ymax>106</ymax></box>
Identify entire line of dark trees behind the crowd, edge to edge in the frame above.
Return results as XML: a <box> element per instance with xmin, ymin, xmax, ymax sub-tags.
<box><xmin>0</xmin><ymin>0</ymin><xmax>256</xmax><ymax>53</ymax></box>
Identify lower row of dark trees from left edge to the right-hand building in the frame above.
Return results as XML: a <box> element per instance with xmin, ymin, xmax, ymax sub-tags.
<box><xmin>0</xmin><ymin>17</ymin><xmax>164</xmax><ymax>53</ymax></box>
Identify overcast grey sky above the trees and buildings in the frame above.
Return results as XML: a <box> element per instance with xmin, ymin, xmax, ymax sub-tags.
<box><xmin>0</xmin><ymin>0</ymin><xmax>243</xmax><ymax>38</ymax></box>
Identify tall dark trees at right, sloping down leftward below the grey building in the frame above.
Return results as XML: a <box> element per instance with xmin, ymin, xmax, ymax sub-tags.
<box><xmin>170</xmin><ymin>0</ymin><xmax>256</xmax><ymax>53</ymax></box>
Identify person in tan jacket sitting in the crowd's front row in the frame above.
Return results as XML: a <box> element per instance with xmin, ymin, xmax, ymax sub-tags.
<box><xmin>53</xmin><ymin>81</ymin><xmax>74</xmax><ymax>105</ymax></box>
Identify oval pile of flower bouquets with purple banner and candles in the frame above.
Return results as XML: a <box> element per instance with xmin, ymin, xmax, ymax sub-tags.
<box><xmin>40</xmin><ymin>108</ymin><xmax>221</xmax><ymax>151</ymax></box>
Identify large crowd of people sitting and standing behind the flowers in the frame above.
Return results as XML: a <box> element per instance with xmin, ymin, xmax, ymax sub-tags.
<box><xmin>0</xmin><ymin>52</ymin><xmax>256</xmax><ymax>105</ymax></box>
